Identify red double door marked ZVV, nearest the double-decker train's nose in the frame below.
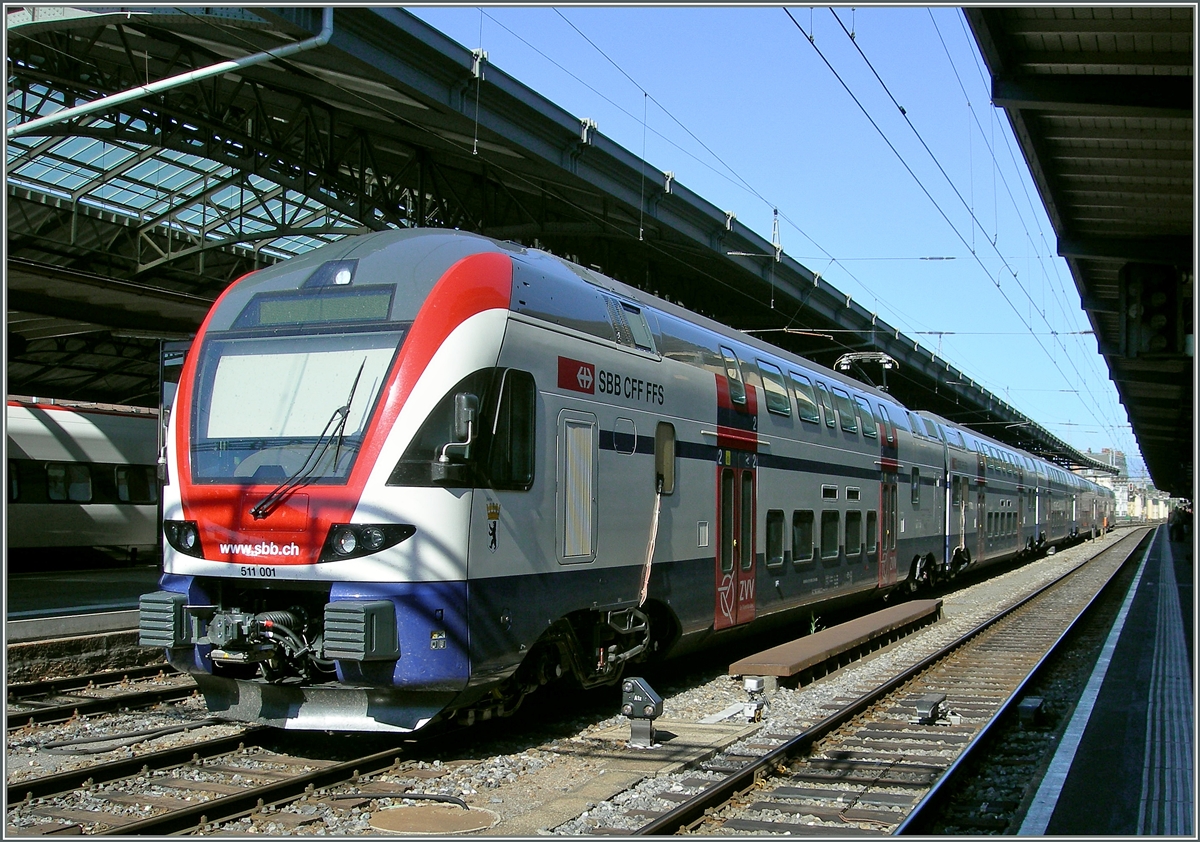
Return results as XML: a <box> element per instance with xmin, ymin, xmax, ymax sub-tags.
<box><xmin>713</xmin><ymin>460</ymin><xmax>755</xmax><ymax>630</ymax></box>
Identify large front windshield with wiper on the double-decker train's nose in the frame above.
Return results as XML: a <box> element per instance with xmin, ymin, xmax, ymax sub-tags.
<box><xmin>191</xmin><ymin>324</ymin><xmax>404</xmax><ymax>483</ymax></box>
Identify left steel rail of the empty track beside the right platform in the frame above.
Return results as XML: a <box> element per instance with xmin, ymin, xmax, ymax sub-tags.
<box><xmin>632</xmin><ymin>534</ymin><xmax>1145</xmax><ymax>836</ymax></box>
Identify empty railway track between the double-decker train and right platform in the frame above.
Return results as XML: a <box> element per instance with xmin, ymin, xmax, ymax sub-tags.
<box><xmin>636</xmin><ymin>530</ymin><xmax>1147</xmax><ymax>836</ymax></box>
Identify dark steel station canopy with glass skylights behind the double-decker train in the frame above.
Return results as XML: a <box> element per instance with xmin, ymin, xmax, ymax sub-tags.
<box><xmin>6</xmin><ymin>6</ymin><xmax>1142</xmax><ymax>482</ymax></box>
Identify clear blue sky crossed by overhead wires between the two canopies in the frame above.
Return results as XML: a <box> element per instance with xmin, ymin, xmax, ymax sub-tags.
<box><xmin>409</xmin><ymin>6</ymin><xmax>1144</xmax><ymax>482</ymax></box>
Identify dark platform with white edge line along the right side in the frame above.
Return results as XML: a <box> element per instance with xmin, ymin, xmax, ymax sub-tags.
<box><xmin>1019</xmin><ymin>525</ymin><xmax>1196</xmax><ymax>837</ymax></box>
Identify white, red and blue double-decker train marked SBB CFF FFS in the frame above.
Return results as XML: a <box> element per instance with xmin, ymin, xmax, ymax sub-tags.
<box><xmin>140</xmin><ymin>229</ymin><xmax>1112</xmax><ymax>732</ymax></box>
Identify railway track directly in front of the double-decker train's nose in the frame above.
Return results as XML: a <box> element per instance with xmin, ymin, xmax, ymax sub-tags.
<box><xmin>7</xmin><ymin>727</ymin><xmax>492</xmax><ymax>836</ymax></box>
